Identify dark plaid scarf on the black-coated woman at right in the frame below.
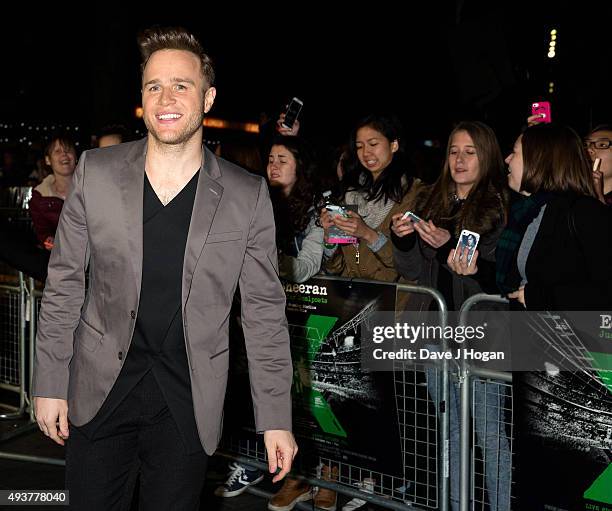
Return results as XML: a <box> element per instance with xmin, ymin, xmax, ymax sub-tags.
<box><xmin>495</xmin><ymin>192</ymin><xmax>552</xmax><ymax>296</ymax></box>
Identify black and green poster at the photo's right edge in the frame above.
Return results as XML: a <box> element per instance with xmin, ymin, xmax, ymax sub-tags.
<box><xmin>514</xmin><ymin>312</ymin><xmax>612</xmax><ymax>511</ymax></box>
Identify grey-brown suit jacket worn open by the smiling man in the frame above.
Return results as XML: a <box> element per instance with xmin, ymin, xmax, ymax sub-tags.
<box><xmin>33</xmin><ymin>139</ymin><xmax>292</xmax><ymax>454</ymax></box>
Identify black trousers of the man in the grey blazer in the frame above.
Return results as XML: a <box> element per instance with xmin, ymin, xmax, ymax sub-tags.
<box><xmin>66</xmin><ymin>371</ymin><xmax>208</xmax><ymax>511</ymax></box>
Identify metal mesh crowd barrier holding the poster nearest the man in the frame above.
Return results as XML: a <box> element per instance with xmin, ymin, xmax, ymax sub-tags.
<box><xmin>220</xmin><ymin>277</ymin><xmax>450</xmax><ymax>511</ymax></box>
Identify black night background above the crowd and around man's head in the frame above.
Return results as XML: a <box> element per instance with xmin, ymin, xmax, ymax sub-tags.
<box><xmin>0</xmin><ymin>0</ymin><xmax>612</xmax><ymax>150</ymax></box>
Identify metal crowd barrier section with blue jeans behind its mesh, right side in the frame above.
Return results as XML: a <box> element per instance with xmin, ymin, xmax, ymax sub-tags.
<box><xmin>459</xmin><ymin>293</ymin><xmax>513</xmax><ymax>511</ymax></box>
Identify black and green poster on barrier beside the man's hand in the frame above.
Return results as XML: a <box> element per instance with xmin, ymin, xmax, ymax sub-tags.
<box><xmin>284</xmin><ymin>279</ymin><xmax>402</xmax><ymax>477</ymax></box>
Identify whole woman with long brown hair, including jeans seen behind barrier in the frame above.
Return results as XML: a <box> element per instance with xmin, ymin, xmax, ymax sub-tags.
<box><xmin>391</xmin><ymin>122</ymin><xmax>511</xmax><ymax>511</ymax></box>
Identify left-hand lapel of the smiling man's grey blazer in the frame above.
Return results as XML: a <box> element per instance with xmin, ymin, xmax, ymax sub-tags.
<box><xmin>121</xmin><ymin>138</ymin><xmax>147</xmax><ymax>299</ymax></box>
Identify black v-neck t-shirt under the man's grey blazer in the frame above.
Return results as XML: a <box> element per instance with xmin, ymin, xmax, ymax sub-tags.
<box><xmin>77</xmin><ymin>171</ymin><xmax>202</xmax><ymax>452</ymax></box>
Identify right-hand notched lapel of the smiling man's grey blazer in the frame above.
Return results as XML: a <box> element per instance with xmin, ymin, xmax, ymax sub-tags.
<box><xmin>182</xmin><ymin>146</ymin><xmax>223</xmax><ymax>306</ymax></box>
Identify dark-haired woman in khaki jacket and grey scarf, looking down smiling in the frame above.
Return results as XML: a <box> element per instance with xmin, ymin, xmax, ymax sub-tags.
<box><xmin>320</xmin><ymin>115</ymin><xmax>418</xmax><ymax>282</ymax></box>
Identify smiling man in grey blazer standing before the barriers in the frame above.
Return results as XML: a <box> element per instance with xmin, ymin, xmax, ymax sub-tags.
<box><xmin>33</xmin><ymin>29</ymin><xmax>297</xmax><ymax>511</ymax></box>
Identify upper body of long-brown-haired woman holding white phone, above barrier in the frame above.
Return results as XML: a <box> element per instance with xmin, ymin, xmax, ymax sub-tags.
<box><xmin>391</xmin><ymin>122</ymin><xmax>507</xmax><ymax>310</ymax></box>
